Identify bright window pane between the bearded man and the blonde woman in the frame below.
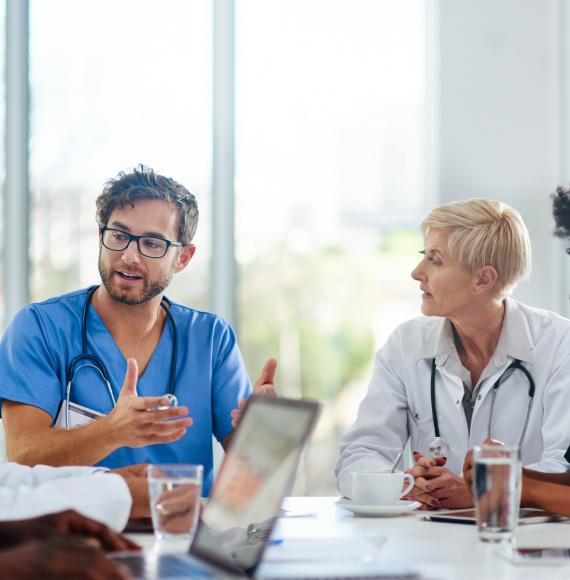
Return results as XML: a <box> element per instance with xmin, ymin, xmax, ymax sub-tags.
<box><xmin>236</xmin><ymin>0</ymin><xmax>426</xmax><ymax>495</ymax></box>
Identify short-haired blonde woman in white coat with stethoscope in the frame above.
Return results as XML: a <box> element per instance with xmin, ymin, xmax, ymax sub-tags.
<box><xmin>336</xmin><ymin>199</ymin><xmax>570</xmax><ymax>508</ymax></box>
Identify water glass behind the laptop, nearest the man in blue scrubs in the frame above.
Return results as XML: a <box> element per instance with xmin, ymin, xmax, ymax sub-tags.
<box><xmin>147</xmin><ymin>463</ymin><xmax>204</xmax><ymax>540</ymax></box>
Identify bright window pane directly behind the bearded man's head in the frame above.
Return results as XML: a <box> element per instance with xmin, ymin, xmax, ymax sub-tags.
<box><xmin>30</xmin><ymin>0</ymin><xmax>212</xmax><ymax>307</ymax></box>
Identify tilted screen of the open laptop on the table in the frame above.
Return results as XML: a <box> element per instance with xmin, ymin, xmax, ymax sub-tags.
<box><xmin>190</xmin><ymin>396</ymin><xmax>319</xmax><ymax>574</ymax></box>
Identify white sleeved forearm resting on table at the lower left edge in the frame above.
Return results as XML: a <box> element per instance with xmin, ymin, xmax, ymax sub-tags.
<box><xmin>0</xmin><ymin>468</ymin><xmax>132</xmax><ymax>531</ymax></box>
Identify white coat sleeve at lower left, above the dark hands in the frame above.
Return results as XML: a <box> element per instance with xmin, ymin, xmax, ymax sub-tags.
<box><xmin>0</xmin><ymin>462</ymin><xmax>132</xmax><ymax>531</ymax></box>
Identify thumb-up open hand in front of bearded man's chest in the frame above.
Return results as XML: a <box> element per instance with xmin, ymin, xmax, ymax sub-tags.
<box><xmin>102</xmin><ymin>358</ymin><xmax>192</xmax><ymax>447</ymax></box>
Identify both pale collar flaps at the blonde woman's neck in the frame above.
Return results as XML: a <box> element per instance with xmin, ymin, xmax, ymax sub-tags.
<box><xmin>412</xmin><ymin>298</ymin><xmax>534</xmax><ymax>367</ymax></box>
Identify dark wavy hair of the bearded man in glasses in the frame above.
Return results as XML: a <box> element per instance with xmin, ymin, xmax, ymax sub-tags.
<box><xmin>97</xmin><ymin>164</ymin><xmax>198</xmax><ymax>244</ymax></box>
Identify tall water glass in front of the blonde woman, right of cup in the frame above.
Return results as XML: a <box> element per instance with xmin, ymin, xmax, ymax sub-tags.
<box><xmin>473</xmin><ymin>445</ymin><xmax>522</xmax><ymax>542</ymax></box>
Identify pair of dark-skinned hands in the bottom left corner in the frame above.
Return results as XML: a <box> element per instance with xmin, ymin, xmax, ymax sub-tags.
<box><xmin>0</xmin><ymin>511</ymin><xmax>140</xmax><ymax>580</ymax></box>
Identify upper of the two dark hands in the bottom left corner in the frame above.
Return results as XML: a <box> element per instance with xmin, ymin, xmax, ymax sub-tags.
<box><xmin>0</xmin><ymin>510</ymin><xmax>140</xmax><ymax>551</ymax></box>
